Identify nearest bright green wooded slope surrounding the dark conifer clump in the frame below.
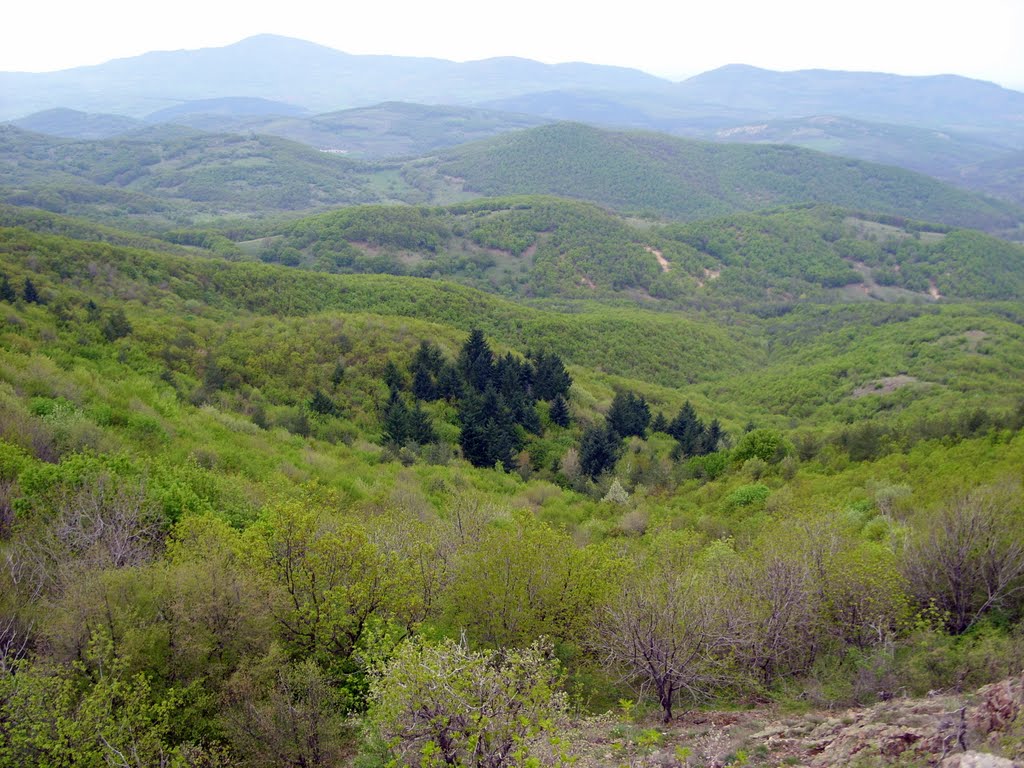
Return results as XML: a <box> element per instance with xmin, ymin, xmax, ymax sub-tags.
<box><xmin>0</xmin><ymin>207</ymin><xmax>1024</xmax><ymax>768</ymax></box>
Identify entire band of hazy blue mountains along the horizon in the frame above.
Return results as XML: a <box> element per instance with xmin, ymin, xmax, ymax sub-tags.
<box><xmin>0</xmin><ymin>35</ymin><xmax>1024</xmax><ymax>203</ymax></box>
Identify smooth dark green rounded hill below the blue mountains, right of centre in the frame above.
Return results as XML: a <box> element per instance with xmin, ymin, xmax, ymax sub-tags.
<box><xmin>415</xmin><ymin>123</ymin><xmax>1021</xmax><ymax>231</ymax></box>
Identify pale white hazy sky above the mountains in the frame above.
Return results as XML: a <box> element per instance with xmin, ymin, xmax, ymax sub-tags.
<box><xmin>6</xmin><ymin>0</ymin><xmax>1024</xmax><ymax>89</ymax></box>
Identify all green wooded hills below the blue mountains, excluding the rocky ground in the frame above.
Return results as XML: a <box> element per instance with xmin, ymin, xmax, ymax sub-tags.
<box><xmin>0</xmin><ymin>61</ymin><xmax>1024</xmax><ymax>768</ymax></box>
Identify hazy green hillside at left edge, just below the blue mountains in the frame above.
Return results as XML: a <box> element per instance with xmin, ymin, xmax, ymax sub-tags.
<box><xmin>0</xmin><ymin>126</ymin><xmax>407</xmax><ymax>226</ymax></box>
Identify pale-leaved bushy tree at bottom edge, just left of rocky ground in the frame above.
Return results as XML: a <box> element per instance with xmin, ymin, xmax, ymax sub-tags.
<box><xmin>368</xmin><ymin>639</ymin><xmax>566</xmax><ymax>768</ymax></box>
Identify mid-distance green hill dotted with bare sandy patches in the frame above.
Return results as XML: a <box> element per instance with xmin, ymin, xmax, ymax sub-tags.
<box><xmin>232</xmin><ymin>197</ymin><xmax>1024</xmax><ymax>308</ymax></box>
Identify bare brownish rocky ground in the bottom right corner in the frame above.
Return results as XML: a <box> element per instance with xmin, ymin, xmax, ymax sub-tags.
<box><xmin>568</xmin><ymin>678</ymin><xmax>1024</xmax><ymax>768</ymax></box>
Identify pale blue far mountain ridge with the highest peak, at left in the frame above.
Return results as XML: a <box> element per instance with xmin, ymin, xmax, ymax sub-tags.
<box><xmin>0</xmin><ymin>35</ymin><xmax>671</xmax><ymax>120</ymax></box>
